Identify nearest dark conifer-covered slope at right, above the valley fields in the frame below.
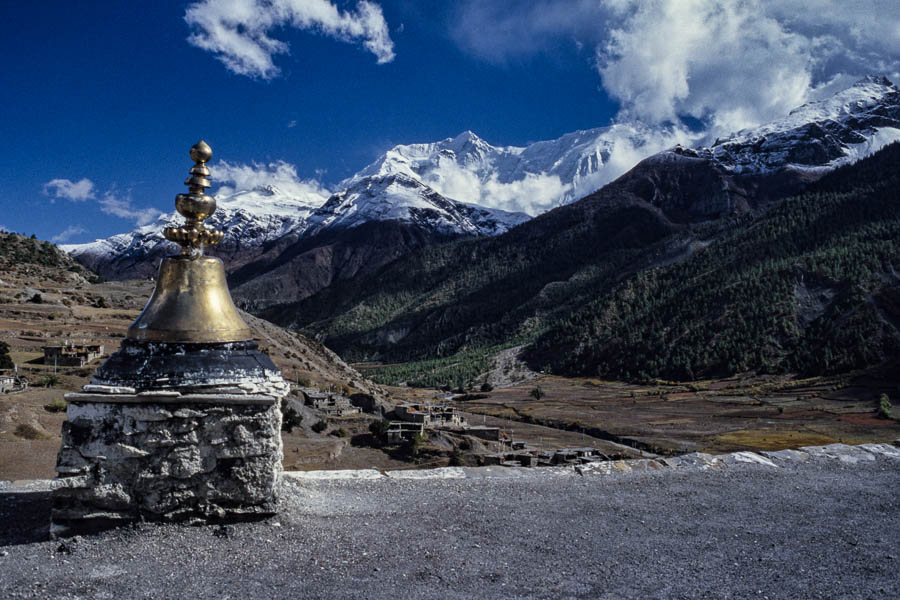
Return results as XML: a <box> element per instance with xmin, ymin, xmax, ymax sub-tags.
<box><xmin>528</xmin><ymin>144</ymin><xmax>900</xmax><ymax>379</ymax></box>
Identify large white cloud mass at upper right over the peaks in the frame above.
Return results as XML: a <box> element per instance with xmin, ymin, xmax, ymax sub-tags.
<box><xmin>451</xmin><ymin>0</ymin><xmax>900</xmax><ymax>135</ymax></box>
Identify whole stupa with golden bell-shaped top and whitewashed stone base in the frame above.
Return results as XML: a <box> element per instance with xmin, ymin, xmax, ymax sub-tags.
<box><xmin>51</xmin><ymin>141</ymin><xmax>289</xmax><ymax>535</ymax></box>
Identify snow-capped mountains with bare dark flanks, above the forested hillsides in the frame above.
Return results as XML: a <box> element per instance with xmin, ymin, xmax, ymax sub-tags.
<box><xmin>66</xmin><ymin>77</ymin><xmax>900</xmax><ymax>322</ymax></box>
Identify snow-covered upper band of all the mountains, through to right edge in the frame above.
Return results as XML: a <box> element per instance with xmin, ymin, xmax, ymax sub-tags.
<box><xmin>62</xmin><ymin>76</ymin><xmax>900</xmax><ymax>268</ymax></box>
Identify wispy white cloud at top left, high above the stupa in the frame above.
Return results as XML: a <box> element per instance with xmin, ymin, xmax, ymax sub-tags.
<box><xmin>184</xmin><ymin>0</ymin><xmax>394</xmax><ymax>79</ymax></box>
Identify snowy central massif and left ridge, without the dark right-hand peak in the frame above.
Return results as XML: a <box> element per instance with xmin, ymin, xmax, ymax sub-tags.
<box><xmin>63</xmin><ymin>117</ymin><xmax>669</xmax><ymax>279</ymax></box>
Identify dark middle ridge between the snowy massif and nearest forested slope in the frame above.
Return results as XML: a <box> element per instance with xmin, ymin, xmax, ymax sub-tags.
<box><xmin>264</xmin><ymin>192</ymin><xmax>684</xmax><ymax>360</ymax></box>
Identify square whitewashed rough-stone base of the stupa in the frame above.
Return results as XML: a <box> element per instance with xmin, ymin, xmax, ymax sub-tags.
<box><xmin>52</xmin><ymin>394</ymin><xmax>282</xmax><ymax>534</ymax></box>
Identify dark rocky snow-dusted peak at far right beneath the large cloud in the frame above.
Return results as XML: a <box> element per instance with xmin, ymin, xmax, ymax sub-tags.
<box><xmin>604</xmin><ymin>77</ymin><xmax>900</xmax><ymax>223</ymax></box>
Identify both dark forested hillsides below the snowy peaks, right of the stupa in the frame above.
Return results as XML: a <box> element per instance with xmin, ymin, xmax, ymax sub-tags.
<box><xmin>266</xmin><ymin>146</ymin><xmax>900</xmax><ymax>379</ymax></box>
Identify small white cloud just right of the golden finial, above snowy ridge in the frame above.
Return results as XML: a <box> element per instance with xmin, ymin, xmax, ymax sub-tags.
<box><xmin>210</xmin><ymin>160</ymin><xmax>330</xmax><ymax>202</ymax></box>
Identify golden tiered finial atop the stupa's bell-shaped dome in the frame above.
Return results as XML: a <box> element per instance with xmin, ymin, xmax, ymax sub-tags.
<box><xmin>163</xmin><ymin>140</ymin><xmax>223</xmax><ymax>256</ymax></box>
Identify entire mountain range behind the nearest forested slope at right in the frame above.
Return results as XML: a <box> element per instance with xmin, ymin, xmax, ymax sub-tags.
<box><xmin>66</xmin><ymin>77</ymin><xmax>900</xmax><ymax>382</ymax></box>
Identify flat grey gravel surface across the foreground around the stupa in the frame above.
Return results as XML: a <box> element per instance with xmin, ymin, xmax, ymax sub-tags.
<box><xmin>0</xmin><ymin>456</ymin><xmax>900</xmax><ymax>599</ymax></box>
